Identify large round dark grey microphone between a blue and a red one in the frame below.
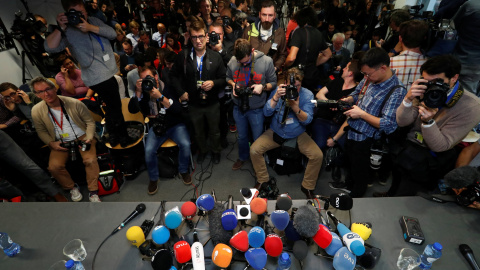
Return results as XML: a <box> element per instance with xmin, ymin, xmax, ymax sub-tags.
<box><xmin>293</xmin><ymin>205</ymin><xmax>320</xmax><ymax>237</ymax></box>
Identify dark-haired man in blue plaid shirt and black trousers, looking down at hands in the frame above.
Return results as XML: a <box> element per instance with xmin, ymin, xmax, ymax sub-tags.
<box><xmin>331</xmin><ymin>48</ymin><xmax>407</xmax><ymax>198</ymax></box>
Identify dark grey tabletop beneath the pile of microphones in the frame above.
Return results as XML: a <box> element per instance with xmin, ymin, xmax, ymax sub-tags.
<box><xmin>0</xmin><ymin>197</ymin><xmax>480</xmax><ymax>270</ymax></box>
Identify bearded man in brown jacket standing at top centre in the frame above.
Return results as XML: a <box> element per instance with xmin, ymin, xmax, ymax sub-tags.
<box><xmin>242</xmin><ymin>0</ymin><xmax>287</xmax><ymax>72</ymax></box>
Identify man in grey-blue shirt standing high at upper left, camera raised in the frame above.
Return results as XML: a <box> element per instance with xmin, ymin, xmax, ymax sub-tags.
<box><xmin>44</xmin><ymin>0</ymin><xmax>131</xmax><ymax>147</ymax></box>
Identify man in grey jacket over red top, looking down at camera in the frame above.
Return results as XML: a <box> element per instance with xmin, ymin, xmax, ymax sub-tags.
<box><xmin>227</xmin><ymin>39</ymin><xmax>277</xmax><ymax>170</ymax></box>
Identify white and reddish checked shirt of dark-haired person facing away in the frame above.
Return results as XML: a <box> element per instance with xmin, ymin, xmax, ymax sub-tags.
<box><xmin>390</xmin><ymin>50</ymin><xmax>427</xmax><ymax>90</ymax></box>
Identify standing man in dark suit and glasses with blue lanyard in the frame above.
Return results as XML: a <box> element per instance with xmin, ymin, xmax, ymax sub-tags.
<box><xmin>170</xmin><ymin>19</ymin><xmax>226</xmax><ymax>164</ymax></box>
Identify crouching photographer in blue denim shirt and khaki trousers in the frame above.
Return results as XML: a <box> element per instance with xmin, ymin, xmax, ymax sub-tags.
<box><xmin>250</xmin><ymin>68</ymin><xmax>323</xmax><ymax>199</ymax></box>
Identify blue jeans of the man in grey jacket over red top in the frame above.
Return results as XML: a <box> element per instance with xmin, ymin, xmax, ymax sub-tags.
<box><xmin>233</xmin><ymin>105</ymin><xmax>264</xmax><ymax>161</ymax></box>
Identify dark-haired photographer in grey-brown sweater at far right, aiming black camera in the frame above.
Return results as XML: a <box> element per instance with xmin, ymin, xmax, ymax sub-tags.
<box><xmin>376</xmin><ymin>55</ymin><xmax>480</xmax><ymax>196</ymax></box>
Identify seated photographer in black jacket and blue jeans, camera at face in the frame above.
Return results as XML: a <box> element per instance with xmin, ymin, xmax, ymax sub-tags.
<box><xmin>136</xmin><ymin>66</ymin><xmax>192</xmax><ymax>195</ymax></box>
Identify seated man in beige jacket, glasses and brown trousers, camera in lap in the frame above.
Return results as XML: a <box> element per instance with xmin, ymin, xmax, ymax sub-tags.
<box><xmin>30</xmin><ymin>77</ymin><xmax>100</xmax><ymax>202</ymax></box>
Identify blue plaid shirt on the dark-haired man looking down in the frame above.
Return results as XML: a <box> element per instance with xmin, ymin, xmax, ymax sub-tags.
<box><xmin>348</xmin><ymin>74</ymin><xmax>407</xmax><ymax>141</ymax></box>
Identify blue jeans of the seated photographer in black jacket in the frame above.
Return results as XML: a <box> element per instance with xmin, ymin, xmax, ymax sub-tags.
<box><xmin>145</xmin><ymin>124</ymin><xmax>190</xmax><ymax>181</ymax></box>
